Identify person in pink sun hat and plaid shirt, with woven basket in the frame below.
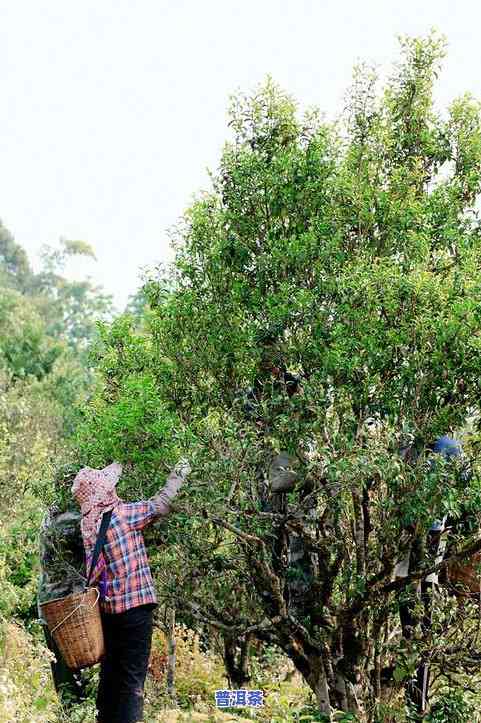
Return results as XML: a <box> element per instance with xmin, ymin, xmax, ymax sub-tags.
<box><xmin>42</xmin><ymin>461</ymin><xmax>190</xmax><ymax>723</ymax></box>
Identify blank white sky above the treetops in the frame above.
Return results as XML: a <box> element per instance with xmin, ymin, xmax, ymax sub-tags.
<box><xmin>0</xmin><ymin>0</ymin><xmax>481</xmax><ymax>306</ymax></box>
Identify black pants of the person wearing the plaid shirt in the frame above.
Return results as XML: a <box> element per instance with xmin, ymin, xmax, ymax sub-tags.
<box><xmin>97</xmin><ymin>604</ymin><xmax>156</xmax><ymax>723</ymax></box>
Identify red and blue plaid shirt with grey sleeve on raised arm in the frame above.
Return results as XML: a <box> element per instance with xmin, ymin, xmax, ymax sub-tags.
<box><xmin>87</xmin><ymin>472</ymin><xmax>183</xmax><ymax>613</ymax></box>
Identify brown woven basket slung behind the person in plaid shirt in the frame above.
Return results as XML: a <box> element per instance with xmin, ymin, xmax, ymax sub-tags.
<box><xmin>40</xmin><ymin>588</ymin><xmax>105</xmax><ymax>670</ymax></box>
